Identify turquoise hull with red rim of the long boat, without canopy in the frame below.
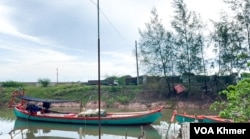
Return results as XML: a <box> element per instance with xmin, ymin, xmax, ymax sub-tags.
<box><xmin>14</xmin><ymin>107</ymin><xmax>162</xmax><ymax>125</ymax></box>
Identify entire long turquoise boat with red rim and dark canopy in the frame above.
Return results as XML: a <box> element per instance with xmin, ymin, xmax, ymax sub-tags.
<box><xmin>10</xmin><ymin>92</ymin><xmax>162</xmax><ymax>125</ymax></box>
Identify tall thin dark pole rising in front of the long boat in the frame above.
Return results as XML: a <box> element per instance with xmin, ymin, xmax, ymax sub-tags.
<box><xmin>97</xmin><ymin>0</ymin><xmax>101</xmax><ymax>139</ymax></box>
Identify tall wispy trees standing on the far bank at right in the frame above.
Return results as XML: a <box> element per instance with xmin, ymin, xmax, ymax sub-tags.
<box><xmin>138</xmin><ymin>0</ymin><xmax>250</xmax><ymax>96</ymax></box>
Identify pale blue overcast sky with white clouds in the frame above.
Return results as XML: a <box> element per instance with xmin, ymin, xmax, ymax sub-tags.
<box><xmin>0</xmin><ymin>0</ymin><xmax>226</xmax><ymax>82</ymax></box>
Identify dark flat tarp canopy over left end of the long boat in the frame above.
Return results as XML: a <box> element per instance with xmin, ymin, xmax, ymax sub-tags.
<box><xmin>15</xmin><ymin>95</ymin><xmax>77</xmax><ymax>103</ymax></box>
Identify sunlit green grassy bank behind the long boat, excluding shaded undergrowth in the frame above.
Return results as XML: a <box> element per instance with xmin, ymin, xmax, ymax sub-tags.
<box><xmin>0</xmin><ymin>84</ymin><xmax>142</xmax><ymax>106</ymax></box>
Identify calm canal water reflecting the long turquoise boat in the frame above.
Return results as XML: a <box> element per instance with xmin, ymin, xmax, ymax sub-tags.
<box><xmin>0</xmin><ymin>108</ymin><xmax>215</xmax><ymax>139</ymax></box>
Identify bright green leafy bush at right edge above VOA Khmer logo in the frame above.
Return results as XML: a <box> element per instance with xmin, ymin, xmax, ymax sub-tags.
<box><xmin>210</xmin><ymin>78</ymin><xmax>250</xmax><ymax>122</ymax></box>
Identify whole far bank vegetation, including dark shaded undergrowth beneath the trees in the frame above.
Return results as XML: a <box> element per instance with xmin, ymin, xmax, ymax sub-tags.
<box><xmin>0</xmin><ymin>75</ymin><xmax>242</xmax><ymax>106</ymax></box>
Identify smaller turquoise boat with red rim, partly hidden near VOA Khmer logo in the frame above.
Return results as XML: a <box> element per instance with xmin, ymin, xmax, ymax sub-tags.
<box><xmin>171</xmin><ymin>110</ymin><xmax>219</xmax><ymax>123</ymax></box>
